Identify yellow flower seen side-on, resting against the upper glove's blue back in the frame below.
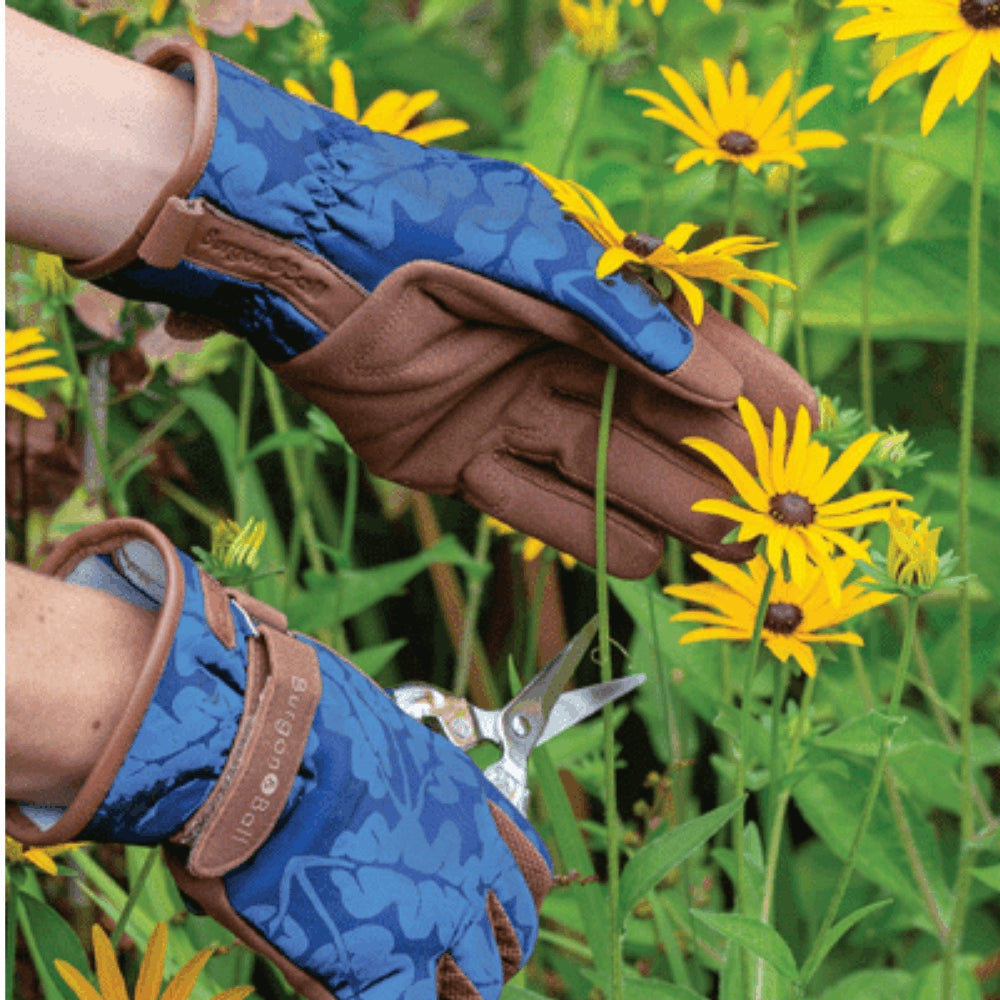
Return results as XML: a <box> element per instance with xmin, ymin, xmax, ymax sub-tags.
<box><xmin>527</xmin><ymin>163</ymin><xmax>794</xmax><ymax>326</ymax></box>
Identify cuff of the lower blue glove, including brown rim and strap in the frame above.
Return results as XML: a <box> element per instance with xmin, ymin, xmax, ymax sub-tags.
<box><xmin>7</xmin><ymin>518</ymin><xmax>322</xmax><ymax>877</ymax></box>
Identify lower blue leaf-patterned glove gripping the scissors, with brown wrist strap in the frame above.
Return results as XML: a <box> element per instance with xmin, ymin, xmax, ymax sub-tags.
<box><xmin>7</xmin><ymin>518</ymin><xmax>551</xmax><ymax>1000</ymax></box>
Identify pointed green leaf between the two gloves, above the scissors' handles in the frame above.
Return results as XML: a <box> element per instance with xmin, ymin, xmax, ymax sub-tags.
<box><xmin>288</xmin><ymin>535</ymin><xmax>476</xmax><ymax>632</ymax></box>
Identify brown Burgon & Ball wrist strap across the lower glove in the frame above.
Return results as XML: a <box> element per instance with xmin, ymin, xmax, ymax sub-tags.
<box><xmin>174</xmin><ymin>625</ymin><xmax>322</xmax><ymax>878</ymax></box>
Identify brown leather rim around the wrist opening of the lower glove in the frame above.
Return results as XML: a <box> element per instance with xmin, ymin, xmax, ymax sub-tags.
<box><xmin>6</xmin><ymin>518</ymin><xmax>184</xmax><ymax>845</ymax></box>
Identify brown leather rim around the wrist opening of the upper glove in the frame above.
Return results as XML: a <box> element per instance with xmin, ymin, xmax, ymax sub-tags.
<box><xmin>66</xmin><ymin>38</ymin><xmax>218</xmax><ymax>281</ymax></box>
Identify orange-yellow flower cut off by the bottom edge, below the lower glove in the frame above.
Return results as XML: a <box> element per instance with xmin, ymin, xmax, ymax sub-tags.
<box><xmin>55</xmin><ymin>922</ymin><xmax>253</xmax><ymax>1000</ymax></box>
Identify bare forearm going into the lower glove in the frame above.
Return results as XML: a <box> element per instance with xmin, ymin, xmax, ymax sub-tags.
<box><xmin>6</xmin><ymin>563</ymin><xmax>156</xmax><ymax>805</ymax></box>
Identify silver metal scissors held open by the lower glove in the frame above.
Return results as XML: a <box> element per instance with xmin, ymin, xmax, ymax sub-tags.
<box><xmin>392</xmin><ymin>616</ymin><xmax>646</xmax><ymax>815</ymax></box>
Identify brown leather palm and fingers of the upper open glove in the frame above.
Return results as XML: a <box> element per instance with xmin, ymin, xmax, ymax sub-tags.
<box><xmin>275</xmin><ymin>261</ymin><xmax>816</xmax><ymax>578</ymax></box>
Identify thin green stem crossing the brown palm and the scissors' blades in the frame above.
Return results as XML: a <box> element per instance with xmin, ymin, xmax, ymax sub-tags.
<box><xmin>594</xmin><ymin>365</ymin><xmax>625</xmax><ymax>1000</ymax></box>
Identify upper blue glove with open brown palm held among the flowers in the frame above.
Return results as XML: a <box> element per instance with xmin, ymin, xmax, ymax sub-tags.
<box><xmin>70</xmin><ymin>41</ymin><xmax>815</xmax><ymax>577</ymax></box>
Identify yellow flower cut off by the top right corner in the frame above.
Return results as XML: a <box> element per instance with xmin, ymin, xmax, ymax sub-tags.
<box><xmin>833</xmin><ymin>0</ymin><xmax>1000</xmax><ymax>135</ymax></box>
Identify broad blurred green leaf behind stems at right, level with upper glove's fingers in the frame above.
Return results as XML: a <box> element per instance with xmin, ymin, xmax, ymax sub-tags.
<box><xmin>804</xmin><ymin>240</ymin><xmax>1000</xmax><ymax>346</ymax></box>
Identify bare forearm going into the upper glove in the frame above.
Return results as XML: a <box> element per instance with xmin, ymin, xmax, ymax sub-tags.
<box><xmin>6</xmin><ymin>8</ymin><xmax>194</xmax><ymax>259</ymax></box>
